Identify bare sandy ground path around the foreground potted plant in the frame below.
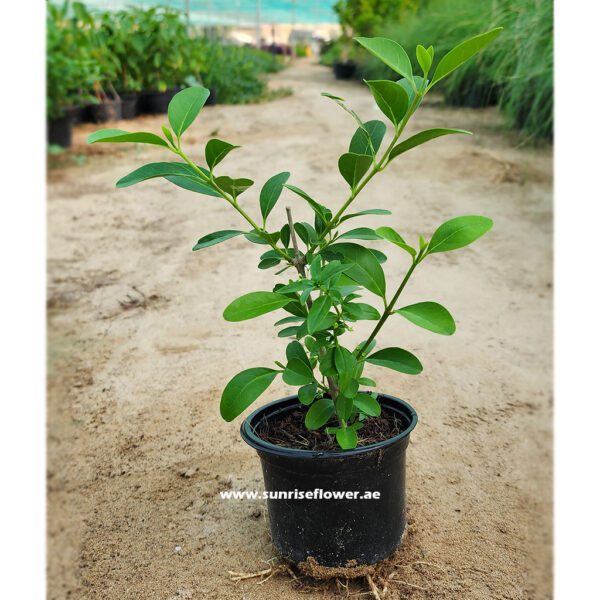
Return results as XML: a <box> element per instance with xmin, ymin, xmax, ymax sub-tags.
<box><xmin>48</xmin><ymin>62</ymin><xmax>552</xmax><ymax>600</ymax></box>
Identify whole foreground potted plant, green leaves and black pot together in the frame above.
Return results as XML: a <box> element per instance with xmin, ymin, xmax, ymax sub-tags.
<box><xmin>88</xmin><ymin>29</ymin><xmax>501</xmax><ymax>574</ymax></box>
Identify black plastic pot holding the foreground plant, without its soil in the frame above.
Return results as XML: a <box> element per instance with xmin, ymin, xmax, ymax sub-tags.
<box><xmin>241</xmin><ymin>394</ymin><xmax>417</xmax><ymax>567</ymax></box>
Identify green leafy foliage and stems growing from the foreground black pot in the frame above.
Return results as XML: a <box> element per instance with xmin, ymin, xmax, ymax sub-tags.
<box><xmin>88</xmin><ymin>29</ymin><xmax>500</xmax><ymax>449</ymax></box>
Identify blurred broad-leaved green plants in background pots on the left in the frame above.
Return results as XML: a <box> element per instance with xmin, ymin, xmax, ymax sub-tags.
<box><xmin>47</xmin><ymin>1</ymin><xmax>283</xmax><ymax>116</ymax></box>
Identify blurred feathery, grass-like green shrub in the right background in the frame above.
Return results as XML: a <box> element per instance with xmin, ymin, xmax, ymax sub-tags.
<box><xmin>359</xmin><ymin>0</ymin><xmax>553</xmax><ymax>138</ymax></box>
